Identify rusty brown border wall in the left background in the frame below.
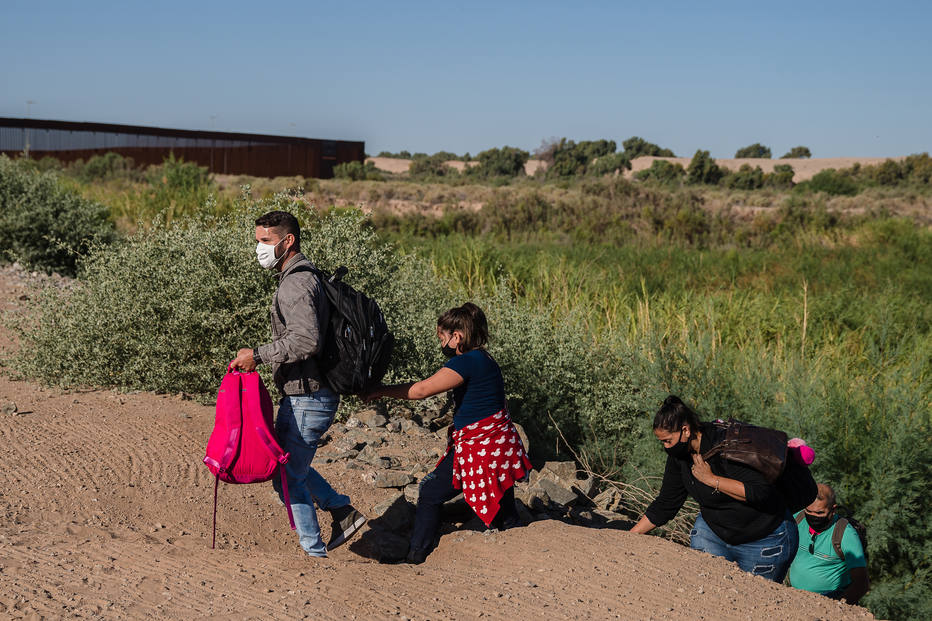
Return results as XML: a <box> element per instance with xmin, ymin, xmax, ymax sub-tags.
<box><xmin>0</xmin><ymin>117</ymin><xmax>365</xmax><ymax>179</ymax></box>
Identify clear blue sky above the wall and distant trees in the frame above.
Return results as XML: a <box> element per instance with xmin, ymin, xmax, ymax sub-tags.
<box><xmin>0</xmin><ymin>0</ymin><xmax>932</xmax><ymax>157</ymax></box>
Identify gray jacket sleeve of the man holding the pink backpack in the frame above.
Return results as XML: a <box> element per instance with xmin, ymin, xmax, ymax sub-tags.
<box><xmin>258</xmin><ymin>273</ymin><xmax>323</xmax><ymax>364</ymax></box>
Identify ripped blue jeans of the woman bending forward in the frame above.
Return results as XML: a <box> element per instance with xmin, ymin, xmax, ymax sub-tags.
<box><xmin>689</xmin><ymin>513</ymin><xmax>799</xmax><ymax>582</ymax></box>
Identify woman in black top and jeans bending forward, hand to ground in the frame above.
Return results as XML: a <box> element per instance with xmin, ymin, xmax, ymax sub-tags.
<box><xmin>631</xmin><ymin>395</ymin><xmax>799</xmax><ymax>582</ymax></box>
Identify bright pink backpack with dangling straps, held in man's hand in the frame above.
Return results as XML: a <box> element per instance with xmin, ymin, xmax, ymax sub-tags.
<box><xmin>204</xmin><ymin>368</ymin><xmax>295</xmax><ymax>548</ymax></box>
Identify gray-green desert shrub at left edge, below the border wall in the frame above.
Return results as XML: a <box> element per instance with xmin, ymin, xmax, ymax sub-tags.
<box><xmin>0</xmin><ymin>156</ymin><xmax>115</xmax><ymax>276</ymax></box>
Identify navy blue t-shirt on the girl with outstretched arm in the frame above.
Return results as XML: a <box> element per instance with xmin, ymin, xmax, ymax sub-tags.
<box><xmin>443</xmin><ymin>349</ymin><xmax>505</xmax><ymax>429</ymax></box>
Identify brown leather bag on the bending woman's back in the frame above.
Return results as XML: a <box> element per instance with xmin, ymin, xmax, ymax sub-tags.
<box><xmin>702</xmin><ymin>419</ymin><xmax>787</xmax><ymax>483</ymax></box>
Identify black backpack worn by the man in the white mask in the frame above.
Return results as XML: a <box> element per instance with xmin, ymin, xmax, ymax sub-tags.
<box><xmin>278</xmin><ymin>265</ymin><xmax>395</xmax><ymax>395</ymax></box>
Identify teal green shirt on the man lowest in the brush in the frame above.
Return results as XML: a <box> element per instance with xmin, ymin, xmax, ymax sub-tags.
<box><xmin>790</xmin><ymin>513</ymin><xmax>867</xmax><ymax>594</ymax></box>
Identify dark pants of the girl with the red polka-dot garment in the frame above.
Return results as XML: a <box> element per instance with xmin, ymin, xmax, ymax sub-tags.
<box><xmin>411</xmin><ymin>450</ymin><xmax>519</xmax><ymax>550</ymax></box>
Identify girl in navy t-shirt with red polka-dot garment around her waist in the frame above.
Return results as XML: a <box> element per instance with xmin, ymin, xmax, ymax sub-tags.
<box><xmin>363</xmin><ymin>302</ymin><xmax>531</xmax><ymax>564</ymax></box>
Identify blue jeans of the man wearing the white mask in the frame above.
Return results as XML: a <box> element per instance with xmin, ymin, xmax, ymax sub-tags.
<box><xmin>273</xmin><ymin>388</ymin><xmax>350</xmax><ymax>556</ymax></box>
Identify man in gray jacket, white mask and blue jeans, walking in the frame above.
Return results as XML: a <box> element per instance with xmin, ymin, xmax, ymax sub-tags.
<box><xmin>231</xmin><ymin>211</ymin><xmax>366</xmax><ymax>557</ymax></box>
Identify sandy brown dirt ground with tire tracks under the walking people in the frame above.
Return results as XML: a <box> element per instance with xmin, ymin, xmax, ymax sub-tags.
<box><xmin>0</xmin><ymin>270</ymin><xmax>873</xmax><ymax>621</ymax></box>
